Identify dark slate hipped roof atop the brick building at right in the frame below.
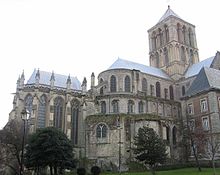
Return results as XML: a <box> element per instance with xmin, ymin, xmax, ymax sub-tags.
<box><xmin>185</xmin><ymin>67</ymin><xmax>220</xmax><ymax>96</ymax></box>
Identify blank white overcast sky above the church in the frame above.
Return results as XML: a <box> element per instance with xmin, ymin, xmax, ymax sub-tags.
<box><xmin>0</xmin><ymin>0</ymin><xmax>220</xmax><ymax>128</ymax></box>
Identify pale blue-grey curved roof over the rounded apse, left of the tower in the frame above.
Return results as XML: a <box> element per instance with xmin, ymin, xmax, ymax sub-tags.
<box><xmin>108</xmin><ymin>58</ymin><xmax>170</xmax><ymax>80</ymax></box>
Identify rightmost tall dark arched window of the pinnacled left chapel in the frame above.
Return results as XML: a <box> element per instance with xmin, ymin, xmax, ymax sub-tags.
<box><xmin>71</xmin><ymin>100</ymin><xmax>80</xmax><ymax>145</ymax></box>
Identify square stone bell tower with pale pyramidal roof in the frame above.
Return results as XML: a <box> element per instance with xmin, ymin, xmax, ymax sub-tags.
<box><xmin>148</xmin><ymin>6</ymin><xmax>199</xmax><ymax>80</ymax></box>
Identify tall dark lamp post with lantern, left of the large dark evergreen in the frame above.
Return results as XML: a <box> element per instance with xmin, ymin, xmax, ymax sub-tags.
<box><xmin>20</xmin><ymin>108</ymin><xmax>30</xmax><ymax>175</ymax></box>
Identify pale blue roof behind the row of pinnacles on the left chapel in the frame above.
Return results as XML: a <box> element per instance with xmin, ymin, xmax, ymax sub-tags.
<box><xmin>26</xmin><ymin>69</ymin><xmax>81</xmax><ymax>90</ymax></box>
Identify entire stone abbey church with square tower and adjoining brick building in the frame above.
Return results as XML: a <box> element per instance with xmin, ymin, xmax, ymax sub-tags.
<box><xmin>9</xmin><ymin>7</ymin><xmax>220</xmax><ymax>169</ymax></box>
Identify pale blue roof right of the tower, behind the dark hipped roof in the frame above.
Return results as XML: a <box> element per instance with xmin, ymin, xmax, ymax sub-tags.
<box><xmin>185</xmin><ymin>56</ymin><xmax>215</xmax><ymax>78</ymax></box>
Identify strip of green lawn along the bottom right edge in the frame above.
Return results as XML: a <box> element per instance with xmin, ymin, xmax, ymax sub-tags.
<box><xmin>108</xmin><ymin>168</ymin><xmax>220</xmax><ymax>175</ymax></box>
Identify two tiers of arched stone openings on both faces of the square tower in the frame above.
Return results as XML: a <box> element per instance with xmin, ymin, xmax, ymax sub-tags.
<box><xmin>150</xmin><ymin>23</ymin><xmax>198</xmax><ymax>68</ymax></box>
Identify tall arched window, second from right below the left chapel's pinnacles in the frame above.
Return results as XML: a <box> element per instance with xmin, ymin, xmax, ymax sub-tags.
<box><xmin>53</xmin><ymin>97</ymin><xmax>64</xmax><ymax>128</ymax></box>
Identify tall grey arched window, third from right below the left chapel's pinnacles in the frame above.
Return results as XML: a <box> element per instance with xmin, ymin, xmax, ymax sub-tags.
<box><xmin>37</xmin><ymin>95</ymin><xmax>47</xmax><ymax>128</ymax></box>
